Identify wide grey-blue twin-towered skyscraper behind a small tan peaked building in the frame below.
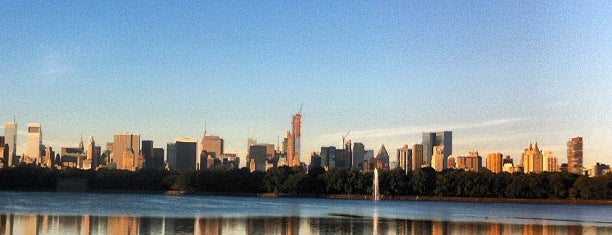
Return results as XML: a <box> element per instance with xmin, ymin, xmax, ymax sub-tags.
<box><xmin>422</xmin><ymin>131</ymin><xmax>453</xmax><ymax>168</ymax></box>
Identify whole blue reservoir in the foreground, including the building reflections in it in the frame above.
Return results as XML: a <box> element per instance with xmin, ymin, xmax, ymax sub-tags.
<box><xmin>0</xmin><ymin>192</ymin><xmax>612</xmax><ymax>235</ymax></box>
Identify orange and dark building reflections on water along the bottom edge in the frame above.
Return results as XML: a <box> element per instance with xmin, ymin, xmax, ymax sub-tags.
<box><xmin>0</xmin><ymin>214</ymin><xmax>612</xmax><ymax>235</ymax></box>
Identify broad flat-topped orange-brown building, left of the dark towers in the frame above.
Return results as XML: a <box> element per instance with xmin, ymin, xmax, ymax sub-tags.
<box><xmin>113</xmin><ymin>133</ymin><xmax>140</xmax><ymax>170</ymax></box>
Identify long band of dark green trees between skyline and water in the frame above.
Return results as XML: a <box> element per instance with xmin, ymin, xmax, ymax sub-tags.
<box><xmin>0</xmin><ymin>165</ymin><xmax>612</xmax><ymax>200</ymax></box>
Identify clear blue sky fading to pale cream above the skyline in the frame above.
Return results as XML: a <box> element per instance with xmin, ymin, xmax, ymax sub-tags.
<box><xmin>0</xmin><ymin>1</ymin><xmax>612</xmax><ymax>165</ymax></box>
